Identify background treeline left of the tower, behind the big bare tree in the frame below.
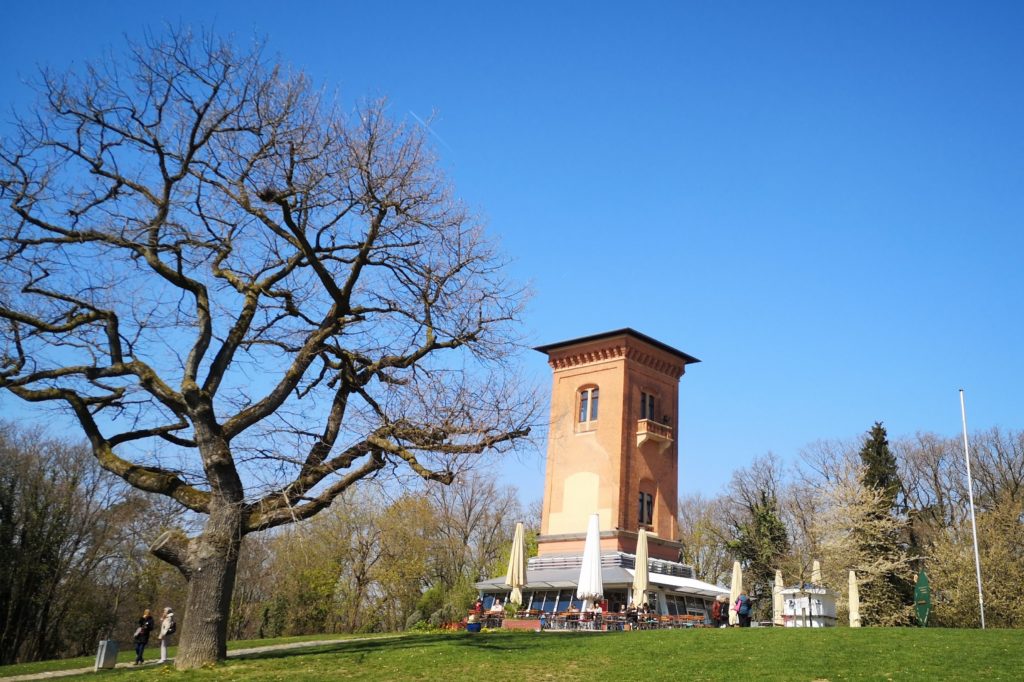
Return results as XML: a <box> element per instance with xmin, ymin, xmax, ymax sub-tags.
<box><xmin>0</xmin><ymin>423</ymin><xmax>539</xmax><ymax>665</ymax></box>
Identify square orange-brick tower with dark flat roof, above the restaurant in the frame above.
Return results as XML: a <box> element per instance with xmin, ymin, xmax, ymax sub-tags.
<box><xmin>537</xmin><ymin>329</ymin><xmax>700</xmax><ymax>561</ymax></box>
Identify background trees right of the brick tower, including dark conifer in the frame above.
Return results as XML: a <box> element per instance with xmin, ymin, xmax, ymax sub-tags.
<box><xmin>680</xmin><ymin>424</ymin><xmax>1024</xmax><ymax>628</ymax></box>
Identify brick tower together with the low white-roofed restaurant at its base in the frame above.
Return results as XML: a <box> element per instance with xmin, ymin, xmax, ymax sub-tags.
<box><xmin>476</xmin><ymin>329</ymin><xmax>728</xmax><ymax>615</ymax></box>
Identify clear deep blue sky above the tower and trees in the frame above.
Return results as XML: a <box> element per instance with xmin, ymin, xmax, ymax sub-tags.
<box><xmin>0</xmin><ymin>0</ymin><xmax>1024</xmax><ymax>499</ymax></box>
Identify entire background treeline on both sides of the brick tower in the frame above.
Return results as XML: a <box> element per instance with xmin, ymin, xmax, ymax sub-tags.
<box><xmin>0</xmin><ymin>417</ymin><xmax>1024</xmax><ymax>664</ymax></box>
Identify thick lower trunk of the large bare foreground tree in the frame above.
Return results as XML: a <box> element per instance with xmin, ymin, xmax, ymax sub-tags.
<box><xmin>174</xmin><ymin>501</ymin><xmax>242</xmax><ymax>670</ymax></box>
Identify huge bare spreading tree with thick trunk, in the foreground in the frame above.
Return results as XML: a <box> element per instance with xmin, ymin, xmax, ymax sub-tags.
<box><xmin>0</xmin><ymin>31</ymin><xmax>534</xmax><ymax>669</ymax></box>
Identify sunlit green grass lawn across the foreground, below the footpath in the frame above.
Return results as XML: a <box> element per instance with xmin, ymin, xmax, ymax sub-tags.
<box><xmin>28</xmin><ymin>628</ymin><xmax>1011</xmax><ymax>682</ymax></box>
